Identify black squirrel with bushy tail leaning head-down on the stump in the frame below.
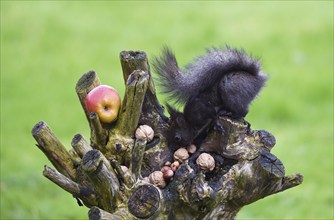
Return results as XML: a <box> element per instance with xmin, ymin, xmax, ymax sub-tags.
<box><xmin>153</xmin><ymin>46</ymin><xmax>267</xmax><ymax>150</ymax></box>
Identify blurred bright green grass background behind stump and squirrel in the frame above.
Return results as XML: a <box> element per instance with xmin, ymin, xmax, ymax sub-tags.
<box><xmin>0</xmin><ymin>1</ymin><xmax>334</xmax><ymax>219</ymax></box>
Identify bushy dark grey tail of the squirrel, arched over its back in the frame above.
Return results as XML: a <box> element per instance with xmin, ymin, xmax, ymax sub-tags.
<box><xmin>153</xmin><ymin>46</ymin><xmax>261</xmax><ymax>102</ymax></box>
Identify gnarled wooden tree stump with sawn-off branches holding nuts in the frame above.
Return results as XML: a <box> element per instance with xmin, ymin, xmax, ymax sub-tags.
<box><xmin>32</xmin><ymin>51</ymin><xmax>303</xmax><ymax>220</ymax></box>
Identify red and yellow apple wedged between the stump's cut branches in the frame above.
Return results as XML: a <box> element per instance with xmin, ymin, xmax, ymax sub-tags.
<box><xmin>86</xmin><ymin>85</ymin><xmax>121</xmax><ymax>123</ymax></box>
